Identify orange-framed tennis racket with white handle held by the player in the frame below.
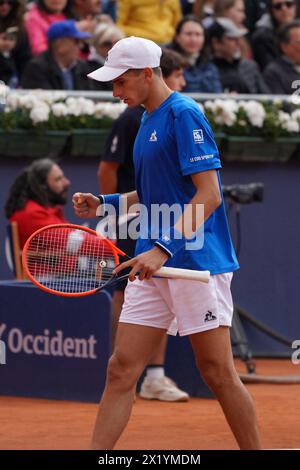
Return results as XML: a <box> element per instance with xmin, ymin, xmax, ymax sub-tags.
<box><xmin>22</xmin><ymin>224</ymin><xmax>210</xmax><ymax>297</ymax></box>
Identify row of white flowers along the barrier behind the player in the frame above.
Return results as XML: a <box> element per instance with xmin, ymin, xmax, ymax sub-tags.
<box><xmin>0</xmin><ymin>89</ymin><xmax>300</xmax><ymax>138</ymax></box>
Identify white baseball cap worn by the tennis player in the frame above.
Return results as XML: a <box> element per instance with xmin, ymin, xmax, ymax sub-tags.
<box><xmin>88</xmin><ymin>36</ymin><xmax>162</xmax><ymax>82</ymax></box>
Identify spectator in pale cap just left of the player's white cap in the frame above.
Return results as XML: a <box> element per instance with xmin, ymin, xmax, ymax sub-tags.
<box><xmin>88</xmin><ymin>23</ymin><xmax>124</xmax><ymax>90</ymax></box>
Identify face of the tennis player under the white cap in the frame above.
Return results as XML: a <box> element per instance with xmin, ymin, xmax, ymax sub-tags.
<box><xmin>112</xmin><ymin>69</ymin><xmax>151</xmax><ymax>108</ymax></box>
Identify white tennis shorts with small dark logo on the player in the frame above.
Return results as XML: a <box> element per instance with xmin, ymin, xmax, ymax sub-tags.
<box><xmin>119</xmin><ymin>273</ymin><xmax>233</xmax><ymax>336</ymax></box>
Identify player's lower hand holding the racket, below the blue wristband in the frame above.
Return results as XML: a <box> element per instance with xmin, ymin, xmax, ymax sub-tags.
<box><xmin>114</xmin><ymin>246</ymin><xmax>169</xmax><ymax>281</ymax></box>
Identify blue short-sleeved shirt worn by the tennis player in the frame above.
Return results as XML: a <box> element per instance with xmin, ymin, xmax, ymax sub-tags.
<box><xmin>133</xmin><ymin>92</ymin><xmax>239</xmax><ymax>274</ymax></box>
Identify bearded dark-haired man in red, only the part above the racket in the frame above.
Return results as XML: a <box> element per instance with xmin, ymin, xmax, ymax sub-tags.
<box><xmin>5</xmin><ymin>158</ymin><xmax>71</xmax><ymax>249</ymax></box>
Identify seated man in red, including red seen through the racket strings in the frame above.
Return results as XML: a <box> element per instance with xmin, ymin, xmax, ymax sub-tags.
<box><xmin>5</xmin><ymin>158</ymin><xmax>113</xmax><ymax>282</ymax></box>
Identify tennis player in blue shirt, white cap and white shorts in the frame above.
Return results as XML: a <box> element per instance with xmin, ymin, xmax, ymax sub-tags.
<box><xmin>73</xmin><ymin>37</ymin><xmax>260</xmax><ymax>450</ymax></box>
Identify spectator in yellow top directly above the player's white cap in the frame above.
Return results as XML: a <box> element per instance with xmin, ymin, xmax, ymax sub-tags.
<box><xmin>117</xmin><ymin>0</ymin><xmax>181</xmax><ymax>44</ymax></box>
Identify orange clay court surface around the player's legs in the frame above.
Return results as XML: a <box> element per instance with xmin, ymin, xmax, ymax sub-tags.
<box><xmin>0</xmin><ymin>359</ymin><xmax>300</xmax><ymax>450</ymax></box>
